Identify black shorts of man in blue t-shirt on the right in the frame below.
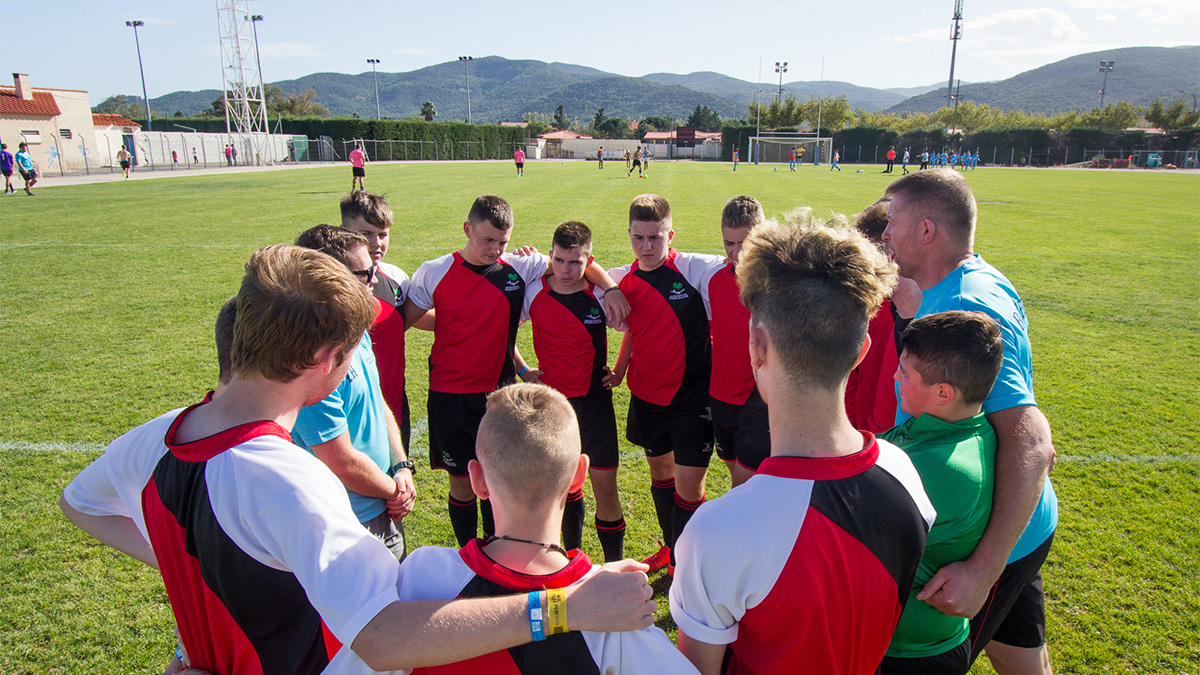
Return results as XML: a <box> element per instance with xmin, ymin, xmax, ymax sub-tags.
<box><xmin>968</xmin><ymin>534</ymin><xmax>1054</xmax><ymax>663</ymax></box>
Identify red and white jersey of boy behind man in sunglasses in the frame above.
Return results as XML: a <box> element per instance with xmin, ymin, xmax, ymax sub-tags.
<box><xmin>371</xmin><ymin>262</ymin><xmax>409</xmax><ymax>419</ymax></box>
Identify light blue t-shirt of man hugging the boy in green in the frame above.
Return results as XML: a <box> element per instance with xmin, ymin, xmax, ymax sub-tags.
<box><xmin>896</xmin><ymin>255</ymin><xmax>1058</xmax><ymax>562</ymax></box>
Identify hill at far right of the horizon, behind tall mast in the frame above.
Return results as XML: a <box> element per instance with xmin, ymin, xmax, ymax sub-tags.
<box><xmin>887</xmin><ymin>47</ymin><xmax>1200</xmax><ymax>114</ymax></box>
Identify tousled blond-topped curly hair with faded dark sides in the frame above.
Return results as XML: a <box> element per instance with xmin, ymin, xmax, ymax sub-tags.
<box><xmin>737</xmin><ymin>210</ymin><xmax>896</xmax><ymax>389</ymax></box>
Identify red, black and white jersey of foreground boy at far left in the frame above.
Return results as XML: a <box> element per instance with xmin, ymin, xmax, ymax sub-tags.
<box><xmin>64</xmin><ymin>401</ymin><xmax>398</xmax><ymax>674</ymax></box>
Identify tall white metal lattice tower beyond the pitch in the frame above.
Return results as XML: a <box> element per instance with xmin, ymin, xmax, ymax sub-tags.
<box><xmin>217</xmin><ymin>0</ymin><xmax>270</xmax><ymax>163</ymax></box>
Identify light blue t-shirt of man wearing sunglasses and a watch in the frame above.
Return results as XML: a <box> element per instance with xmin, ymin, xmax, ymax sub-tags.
<box><xmin>292</xmin><ymin>334</ymin><xmax>391</xmax><ymax>522</ymax></box>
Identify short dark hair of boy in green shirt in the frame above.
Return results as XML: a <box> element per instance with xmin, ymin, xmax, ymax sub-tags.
<box><xmin>900</xmin><ymin>311</ymin><xmax>1004</xmax><ymax>404</ymax></box>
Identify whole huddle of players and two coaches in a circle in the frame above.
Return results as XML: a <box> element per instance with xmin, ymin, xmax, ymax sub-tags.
<box><xmin>60</xmin><ymin>169</ymin><xmax>1057</xmax><ymax>674</ymax></box>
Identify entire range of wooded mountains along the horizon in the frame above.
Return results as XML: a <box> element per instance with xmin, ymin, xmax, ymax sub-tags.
<box><xmin>145</xmin><ymin>47</ymin><xmax>1200</xmax><ymax>123</ymax></box>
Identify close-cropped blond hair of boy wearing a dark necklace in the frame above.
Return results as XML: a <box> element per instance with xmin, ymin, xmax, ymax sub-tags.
<box><xmin>475</xmin><ymin>382</ymin><xmax>580</xmax><ymax>506</ymax></box>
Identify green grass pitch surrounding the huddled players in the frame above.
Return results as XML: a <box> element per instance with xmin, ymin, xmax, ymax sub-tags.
<box><xmin>0</xmin><ymin>162</ymin><xmax>1200</xmax><ymax>675</ymax></box>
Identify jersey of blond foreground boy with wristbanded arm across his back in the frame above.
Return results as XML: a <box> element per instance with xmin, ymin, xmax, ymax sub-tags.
<box><xmin>400</xmin><ymin>539</ymin><xmax>696</xmax><ymax>675</ymax></box>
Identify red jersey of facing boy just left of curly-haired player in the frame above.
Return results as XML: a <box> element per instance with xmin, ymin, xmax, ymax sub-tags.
<box><xmin>700</xmin><ymin>263</ymin><xmax>755</xmax><ymax>406</ymax></box>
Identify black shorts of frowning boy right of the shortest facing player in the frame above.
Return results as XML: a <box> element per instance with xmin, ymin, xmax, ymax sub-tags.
<box><xmin>625</xmin><ymin>396</ymin><xmax>713</xmax><ymax>467</ymax></box>
